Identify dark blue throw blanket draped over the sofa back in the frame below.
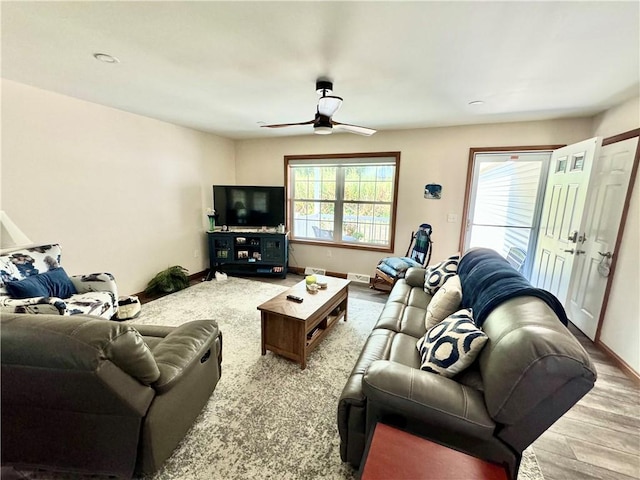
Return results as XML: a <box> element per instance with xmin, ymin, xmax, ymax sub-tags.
<box><xmin>458</xmin><ymin>248</ymin><xmax>569</xmax><ymax>327</ymax></box>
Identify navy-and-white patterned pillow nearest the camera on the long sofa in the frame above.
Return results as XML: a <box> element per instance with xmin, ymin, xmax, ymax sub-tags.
<box><xmin>416</xmin><ymin>309</ymin><xmax>489</xmax><ymax>378</ymax></box>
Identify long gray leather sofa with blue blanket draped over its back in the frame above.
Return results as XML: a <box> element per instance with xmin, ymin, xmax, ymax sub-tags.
<box><xmin>338</xmin><ymin>252</ymin><xmax>596</xmax><ymax>479</ymax></box>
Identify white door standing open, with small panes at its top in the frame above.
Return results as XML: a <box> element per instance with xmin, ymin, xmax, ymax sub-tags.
<box><xmin>531</xmin><ymin>138</ymin><xmax>602</xmax><ymax>307</ymax></box>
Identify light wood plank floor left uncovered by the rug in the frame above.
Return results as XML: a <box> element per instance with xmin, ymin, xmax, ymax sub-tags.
<box><xmin>246</xmin><ymin>274</ymin><xmax>640</xmax><ymax>480</ymax></box>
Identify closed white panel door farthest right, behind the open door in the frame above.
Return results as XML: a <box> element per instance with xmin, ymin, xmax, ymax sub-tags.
<box><xmin>565</xmin><ymin>137</ymin><xmax>638</xmax><ymax>340</ymax></box>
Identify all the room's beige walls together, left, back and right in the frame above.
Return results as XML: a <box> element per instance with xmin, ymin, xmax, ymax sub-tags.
<box><xmin>0</xmin><ymin>80</ymin><xmax>640</xmax><ymax>371</ymax></box>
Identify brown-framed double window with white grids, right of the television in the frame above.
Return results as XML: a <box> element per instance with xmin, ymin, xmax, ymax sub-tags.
<box><xmin>285</xmin><ymin>152</ymin><xmax>400</xmax><ymax>251</ymax></box>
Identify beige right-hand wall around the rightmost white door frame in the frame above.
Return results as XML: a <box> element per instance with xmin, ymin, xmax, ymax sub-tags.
<box><xmin>593</xmin><ymin>98</ymin><xmax>640</xmax><ymax>375</ymax></box>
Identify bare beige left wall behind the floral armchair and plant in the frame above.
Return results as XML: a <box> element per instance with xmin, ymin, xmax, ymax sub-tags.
<box><xmin>0</xmin><ymin>80</ymin><xmax>235</xmax><ymax>294</ymax></box>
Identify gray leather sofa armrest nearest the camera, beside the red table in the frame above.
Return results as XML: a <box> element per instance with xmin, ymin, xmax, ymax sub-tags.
<box><xmin>362</xmin><ymin>360</ymin><xmax>495</xmax><ymax>438</ymax></box>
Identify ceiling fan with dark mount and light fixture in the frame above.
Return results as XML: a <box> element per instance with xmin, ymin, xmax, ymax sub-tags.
<box><xmin>261</xmin><ymin>80</ymin><xmax>376</xmax><ymax>136</ymax></box>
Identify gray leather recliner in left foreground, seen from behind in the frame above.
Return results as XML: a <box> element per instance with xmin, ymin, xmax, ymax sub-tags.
<box><xmin>0</xmin><ymin>313</ymin><xmax>222</xmax><ymax>477</ymax></box>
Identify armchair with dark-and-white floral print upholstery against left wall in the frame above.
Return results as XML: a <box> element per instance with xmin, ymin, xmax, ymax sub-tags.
<box><xmin>0</xmin><ymin>244</ymin><xmax>118</xmax><ymax>320</ymax></box>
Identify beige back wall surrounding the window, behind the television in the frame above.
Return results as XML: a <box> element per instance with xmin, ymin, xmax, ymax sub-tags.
<box><xmin>236</xmin><ymin>118</ymin><xmax>592</xmax><ymax>275</ymax></box>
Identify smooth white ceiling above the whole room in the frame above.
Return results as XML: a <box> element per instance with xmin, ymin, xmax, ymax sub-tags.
<box><xmin>1</xmin><ymin>1</ymin><xmax>640</xmax><ymax>139</ymax></box>
